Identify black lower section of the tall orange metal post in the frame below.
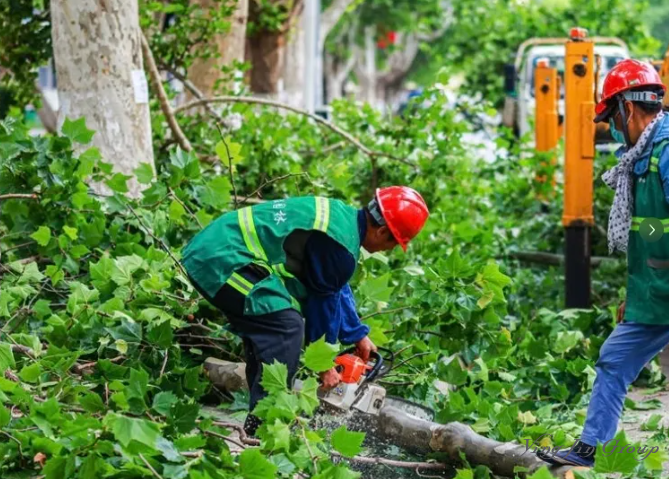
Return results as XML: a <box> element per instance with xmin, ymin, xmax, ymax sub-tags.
<box><xmin>565</xmin><ymin>224</ymin><xmax>591</xmax><ymax>309</ymax></box>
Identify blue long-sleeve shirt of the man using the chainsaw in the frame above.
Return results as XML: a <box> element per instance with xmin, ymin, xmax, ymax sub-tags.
<box><xmin>301</xmin><ymin>210</ymin><xmax>369</xmax><ymax>344</ymax></box>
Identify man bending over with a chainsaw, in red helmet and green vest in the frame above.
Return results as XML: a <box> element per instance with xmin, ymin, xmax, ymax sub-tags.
<box><xmin>182</xmin><ymin>186</ymin><xmax>429</xmax><ymax>435</ymax></box>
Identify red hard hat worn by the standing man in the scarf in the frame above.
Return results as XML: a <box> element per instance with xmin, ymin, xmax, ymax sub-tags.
<box><xmin>595</xmin><ymin>59</ymin><xmax>667</xmax><ymax>123</ymax></box>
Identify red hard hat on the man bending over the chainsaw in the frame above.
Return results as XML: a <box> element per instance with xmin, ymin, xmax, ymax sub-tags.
<box><xmin>376</xmin><ymin>186</ymin><xmax>430</xmax><ymax>251</ymax></box>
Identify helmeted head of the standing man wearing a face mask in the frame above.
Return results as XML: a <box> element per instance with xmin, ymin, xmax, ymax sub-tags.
<box><xmin>595</xmin><ymin>60</ymin><xmax>666</xmax><ymax>148</ymax></box>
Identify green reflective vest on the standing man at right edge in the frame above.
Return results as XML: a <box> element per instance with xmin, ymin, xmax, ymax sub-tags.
<box><xmin>625</xmin><ymin>140</ymin><xmax>669</xmax><ymax>324</ymax></box>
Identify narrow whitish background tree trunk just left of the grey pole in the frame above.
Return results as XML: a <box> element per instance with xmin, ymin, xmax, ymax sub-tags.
<box><xmin>280</xmin><ymin>15</ymin><xmax>306</xmax><ymax>108</ymax></box>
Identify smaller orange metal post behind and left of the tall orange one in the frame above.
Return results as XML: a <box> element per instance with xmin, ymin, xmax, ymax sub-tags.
<box><xmin>534</xmin><ymin>58</ymin><xmax>560</xmax><ymax>191</ymax></box>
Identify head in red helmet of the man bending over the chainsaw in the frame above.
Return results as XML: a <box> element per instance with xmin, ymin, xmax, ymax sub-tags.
<box><xmin>362</xmin><ymin>186</ymin><xmax>430</xmax><ymax>253</ymax></box>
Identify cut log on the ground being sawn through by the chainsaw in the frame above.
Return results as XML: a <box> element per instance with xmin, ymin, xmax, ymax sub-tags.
<box><xmin>204</xmin><ymin>358</ymin><xmax>577</xmax><ymax>479</ymax></box>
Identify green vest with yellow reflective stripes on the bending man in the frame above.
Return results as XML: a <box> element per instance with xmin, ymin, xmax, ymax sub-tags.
<box><xmin>182</xmin><ymin>196</ymin><xmax>361</xmax><ymax>316</ymax></box>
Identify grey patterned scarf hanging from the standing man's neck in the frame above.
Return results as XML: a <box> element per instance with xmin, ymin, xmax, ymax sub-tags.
<box><xmin>602</xmin><ymin>112</ymin><xmax>664</xmax><ymax>253</ymax></box>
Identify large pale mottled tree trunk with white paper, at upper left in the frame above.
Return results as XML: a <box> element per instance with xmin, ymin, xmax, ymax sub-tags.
<box><xmin>51</xmin><ymin>0</ymin><xmax>154</xmax><ymax>197</ymax></box>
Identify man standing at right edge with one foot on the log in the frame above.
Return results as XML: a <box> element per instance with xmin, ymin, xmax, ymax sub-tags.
<box><xmin>538</xmin><ymin>60</ymin><xmax>669</xmax><ymax>466</ymax></box>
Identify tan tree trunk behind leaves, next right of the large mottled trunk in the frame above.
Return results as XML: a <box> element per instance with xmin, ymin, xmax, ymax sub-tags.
<box><xmin>187</xmin><ymin>0</ymin><xmax>249</xmax><ymax>101</ymax></box>
